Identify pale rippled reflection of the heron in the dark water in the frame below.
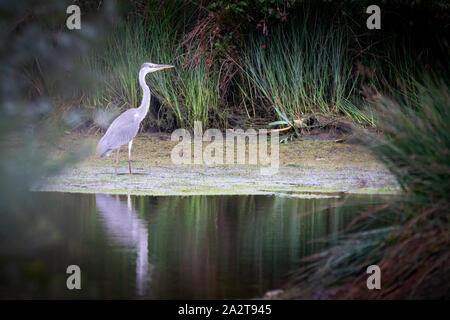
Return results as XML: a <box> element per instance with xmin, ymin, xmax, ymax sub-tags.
<box><xmin>95</xmin><ymin>194</ymin><xmax>152</xmax><ymax>296</ymax></box>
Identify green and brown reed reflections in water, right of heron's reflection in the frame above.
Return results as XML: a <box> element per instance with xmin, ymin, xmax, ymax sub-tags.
<box><xmin>149</xmin><ymin>195</ymin><xmax>371</xmax><ymax>298</ymax></box>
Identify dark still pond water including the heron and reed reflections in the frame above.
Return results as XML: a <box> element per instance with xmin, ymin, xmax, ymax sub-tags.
<box><xmin>0</xmin><ymin>193</ymin><xmax>388</xmax><ymax>299</ymax></box>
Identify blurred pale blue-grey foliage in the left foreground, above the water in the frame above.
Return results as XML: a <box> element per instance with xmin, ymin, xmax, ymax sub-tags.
<box><xmin>0</xmin><ymin>1</ymin><xmax>116</xmax><ymax>202</ymax></box>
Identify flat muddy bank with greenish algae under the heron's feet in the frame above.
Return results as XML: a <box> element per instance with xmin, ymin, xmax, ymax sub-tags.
<box><xmin>36</xmin><ymin>134</ymin><xmax>398</xmax><ymax>196</ymax></box>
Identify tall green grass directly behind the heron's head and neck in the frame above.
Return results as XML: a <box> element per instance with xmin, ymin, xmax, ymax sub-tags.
<box><xmin>83</xmin><ymin>13</ymin><xmax>217</xmax><ymax>129</ymax></box>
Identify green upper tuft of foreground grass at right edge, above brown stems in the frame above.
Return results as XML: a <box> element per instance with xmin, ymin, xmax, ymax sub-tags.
<box><xmin>370</xmin><ymin>80</ymin><xmax>450</xmax><ymax>205</ymax></box>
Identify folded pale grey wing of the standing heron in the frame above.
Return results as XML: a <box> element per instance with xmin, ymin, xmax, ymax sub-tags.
<box><xmin>98</xmin><ymin>109</ymin><xmax>140</xmax><ymax>156</ymax></box>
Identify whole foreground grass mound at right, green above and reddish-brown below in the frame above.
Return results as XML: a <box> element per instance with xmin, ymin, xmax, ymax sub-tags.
<box><xmin>292</xmin><ymin>80</ymin><xmax>450</xmax><ymax>298</ymax></box>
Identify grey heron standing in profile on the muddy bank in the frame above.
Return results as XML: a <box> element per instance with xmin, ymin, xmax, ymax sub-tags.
<box><xmin>97</xmin><ymin>63</ymin><xmax>174</xmax><ymax>174</ymax></box>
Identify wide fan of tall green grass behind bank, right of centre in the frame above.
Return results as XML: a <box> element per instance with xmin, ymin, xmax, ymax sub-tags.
<box><xmin>240</xmin><ymin>14</ymin><xmax>373</xmax><ymax>130</ymax></box>
